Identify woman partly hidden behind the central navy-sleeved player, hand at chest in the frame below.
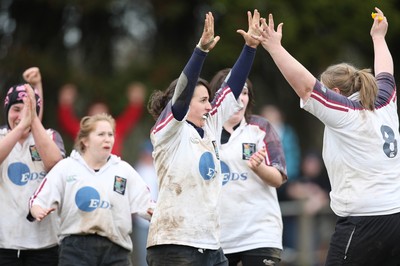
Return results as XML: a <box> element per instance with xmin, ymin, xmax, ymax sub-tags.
<box><xmin>210</xmin><ymin>69</ymin><xmax>287</xmax><ymax>266</ymax></box>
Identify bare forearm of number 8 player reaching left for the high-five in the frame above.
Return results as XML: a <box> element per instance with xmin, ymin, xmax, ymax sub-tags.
<box><xmin>269</xmin><ymin>46</ymin><xmax>316</xmax><ymax>100</ymax></box>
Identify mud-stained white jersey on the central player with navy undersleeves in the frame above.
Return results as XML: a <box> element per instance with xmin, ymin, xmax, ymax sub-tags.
<box><xmin>147</xmin><ymin>87</ymin><xmax>240</xmax><ymax>249</ymax></box>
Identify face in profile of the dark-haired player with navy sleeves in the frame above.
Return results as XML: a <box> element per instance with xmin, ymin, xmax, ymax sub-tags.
<box><xmin>187</xmin><ymin>85</ymin><xmax>211</xmax><ymax>127</ymax></box>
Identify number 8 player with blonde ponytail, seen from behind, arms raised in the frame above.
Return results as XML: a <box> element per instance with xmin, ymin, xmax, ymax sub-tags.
<box><xmin>254</xmin><ymin>8</ymin><xmax>400</xmax><ymax>266</ymax></box>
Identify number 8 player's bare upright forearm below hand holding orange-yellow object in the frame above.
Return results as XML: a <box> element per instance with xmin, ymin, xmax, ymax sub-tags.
<box><xmin>372</xmin><ymin>36</ymin><xmax>394</xmax><ymax>75</ymax></box>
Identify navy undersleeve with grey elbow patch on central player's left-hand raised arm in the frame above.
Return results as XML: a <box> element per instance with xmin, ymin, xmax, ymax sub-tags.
<box><xmin>172</xmin><ymin>47</ymin><xmax>207</xmax><ymax>121</ymax></box>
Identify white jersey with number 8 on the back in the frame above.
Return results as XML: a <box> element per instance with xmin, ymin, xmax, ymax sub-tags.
<box><xmin>301</xmin><ymin>73</ymin><xmax>400</xmax><ymax>217</ymax></box>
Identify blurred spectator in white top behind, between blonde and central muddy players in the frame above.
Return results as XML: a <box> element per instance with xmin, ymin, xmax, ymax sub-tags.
<box><xmin>131</xmin><ymin>140</ymin><xmax>158</xmax><ymax>266</ymax></box>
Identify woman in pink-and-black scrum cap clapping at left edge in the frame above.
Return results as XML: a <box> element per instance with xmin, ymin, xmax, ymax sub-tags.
<box><xmin>0</xmin><ymin>84</ymin><xmax>65</xmax><ymax>266</ymax></box>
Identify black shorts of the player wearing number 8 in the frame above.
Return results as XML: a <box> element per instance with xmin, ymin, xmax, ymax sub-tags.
<box><xmin>325</xmin><ymin>213</ymin><xmax>400</xmax><ymax>266</ymax></box>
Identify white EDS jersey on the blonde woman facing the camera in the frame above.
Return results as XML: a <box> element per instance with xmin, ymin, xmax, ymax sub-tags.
<box><xmin>29</xmin><ymin>151</ymin><xmax>151</xmax><ymax>250</ymax></box>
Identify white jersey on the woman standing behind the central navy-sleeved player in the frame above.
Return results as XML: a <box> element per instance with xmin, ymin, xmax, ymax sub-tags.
<box><xmin>220</xmin><ymin>116</ymin><xmax>286</xmax><ymax>254</ymax></box>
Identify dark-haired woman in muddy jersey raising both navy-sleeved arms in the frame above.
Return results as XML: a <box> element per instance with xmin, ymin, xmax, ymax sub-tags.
<box><xmin>147</xmin><ymin>10</ymin><xmax>260</xmax><ymax>266</ymax></box>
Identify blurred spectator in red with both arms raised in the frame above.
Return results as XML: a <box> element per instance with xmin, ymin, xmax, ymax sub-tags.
<box><xmin>57</xmin><ymin>82</ymin><xmax>145</xmax><ymax>156</ymax></box>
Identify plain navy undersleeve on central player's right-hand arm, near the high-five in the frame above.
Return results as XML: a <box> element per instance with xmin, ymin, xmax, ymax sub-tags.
<box><xmin>226</xmin><ymin>45</ymin><xmax>257</xmax><ymax>99</ymax></box>
